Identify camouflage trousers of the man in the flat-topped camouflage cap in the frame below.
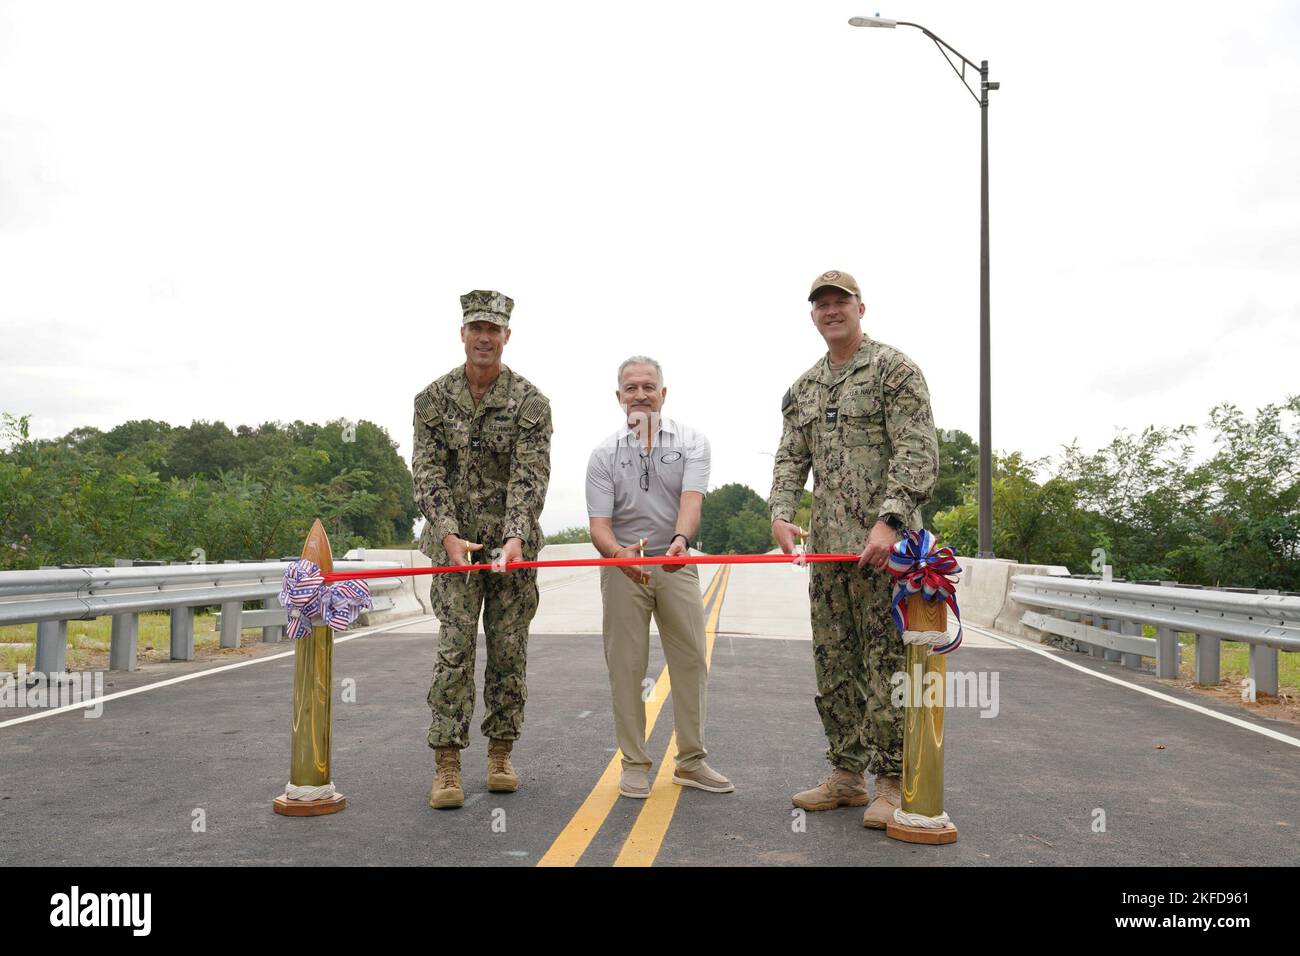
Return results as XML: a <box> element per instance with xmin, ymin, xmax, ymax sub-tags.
<box><xmin>429</xmin><ymin>571</ymin><xmax>537</xmax><ymax>749</ymax></box>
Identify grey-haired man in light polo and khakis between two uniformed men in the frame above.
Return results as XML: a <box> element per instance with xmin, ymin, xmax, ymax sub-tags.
<box><xmin>586</xmin><ymin>355</ymin><xmax>735</xmax><ymax>800</ymax></box>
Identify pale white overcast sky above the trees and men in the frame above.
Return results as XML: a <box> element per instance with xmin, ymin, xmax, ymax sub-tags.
<box><xmin>0</xmin><ymin>0</ymin><xmax>1300</xmax><ymax>532</ymax></box>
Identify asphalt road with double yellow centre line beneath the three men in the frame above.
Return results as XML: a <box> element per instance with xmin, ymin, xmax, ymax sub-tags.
<box><xmin>0</xmin><ymin>566</ymin><xmax>1300</xmax><ymax>866</ymax></box>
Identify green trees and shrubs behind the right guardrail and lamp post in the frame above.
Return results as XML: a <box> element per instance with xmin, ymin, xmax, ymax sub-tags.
<box><xmin>933</xmin><ymin>395</ymin><xmax>1300</xmax><ymax>591</ymax></box>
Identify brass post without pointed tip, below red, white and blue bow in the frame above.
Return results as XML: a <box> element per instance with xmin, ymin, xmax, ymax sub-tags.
<box><xmin>885</xmin><ymin>594</ymin><xmax>957</xmax><ymax>844</ymax></box>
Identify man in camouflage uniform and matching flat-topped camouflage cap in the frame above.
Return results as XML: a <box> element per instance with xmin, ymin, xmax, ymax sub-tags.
<box><xmin>412</xmin><ymin>290</ymin><xmax>551</xmax><ymax>808</ymax></box>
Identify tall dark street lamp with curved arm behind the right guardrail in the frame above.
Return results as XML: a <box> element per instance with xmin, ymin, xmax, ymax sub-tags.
<box><xmin>849</xmin><ymin>17</ymin><xmax>1001</xmax><ymax>558</ymax></box>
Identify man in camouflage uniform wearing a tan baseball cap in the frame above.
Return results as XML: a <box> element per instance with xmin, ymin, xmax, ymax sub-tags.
<box><xmin>768</xmin><ymin>271</ymin><xmax>939</xmax><ymax>830</ymax></box>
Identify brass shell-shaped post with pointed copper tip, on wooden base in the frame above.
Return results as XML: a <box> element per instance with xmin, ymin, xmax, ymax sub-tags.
<box><xmin>272</xmin><ymin>518</ymin><xmax>347</xmax><ymax>817</ymax></box>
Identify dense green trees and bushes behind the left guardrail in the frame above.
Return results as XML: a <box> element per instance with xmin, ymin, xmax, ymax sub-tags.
<box><xmin>0</xmin><ymin>414</ymin><xmax>416</xmax><ymax>570</ymax></box>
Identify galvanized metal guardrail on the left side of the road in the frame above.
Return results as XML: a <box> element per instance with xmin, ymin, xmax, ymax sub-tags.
<box><xmin>0</xmin><ymin>561</ymin><xmax>402</xmax><ymax>674</ymax></box>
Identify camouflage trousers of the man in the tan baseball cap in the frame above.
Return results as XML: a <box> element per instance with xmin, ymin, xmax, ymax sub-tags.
<box><xmin>809</xmin><ymin>563</ymin><xmax>907</xmax><ymax>777</ymax></box>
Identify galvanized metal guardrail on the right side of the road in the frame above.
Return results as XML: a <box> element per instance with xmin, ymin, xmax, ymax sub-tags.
<box><xmin>1010</xmin><ymin>575</ymin><xmax>1300</xmax><ymax>695</ymax></box>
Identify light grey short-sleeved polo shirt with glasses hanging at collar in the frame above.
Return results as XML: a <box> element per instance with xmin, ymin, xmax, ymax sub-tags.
<box><xmin>586</xmin><ymin>418</ymin><xmax>710</xmax><ymax>554</ymax></box>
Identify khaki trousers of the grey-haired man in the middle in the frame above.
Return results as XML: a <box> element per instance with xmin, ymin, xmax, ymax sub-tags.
<box><xmin>601</xmin><ymin>564</ymin><xmax>709</xmax><ymax>770</ymax></box>
